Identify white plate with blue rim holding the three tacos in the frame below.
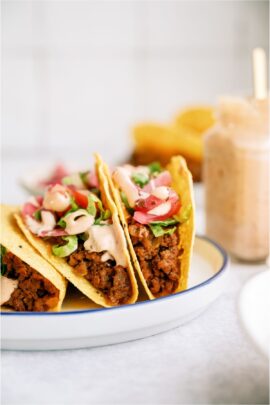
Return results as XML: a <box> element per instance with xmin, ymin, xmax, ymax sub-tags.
<box><xmin>2</xmin><ymin>237</ymin><xmax>228</xmax><ymax>350</ymax></box>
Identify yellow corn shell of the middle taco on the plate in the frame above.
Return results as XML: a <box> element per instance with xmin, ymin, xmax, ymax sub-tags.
<box><xmin>15</xmin><ymin>155</ymin><xmax>138</xmax><ymax>307</ymax></box>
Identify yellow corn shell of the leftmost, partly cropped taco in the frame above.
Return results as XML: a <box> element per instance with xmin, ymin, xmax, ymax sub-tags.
<box><xmin>0</xmin><ymin>205</ymin><xmax>67</xmax><ymax>311</ymax></box>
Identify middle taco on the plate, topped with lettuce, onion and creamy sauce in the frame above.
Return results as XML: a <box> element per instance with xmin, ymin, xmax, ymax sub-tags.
<box><xmin>16</xmin><ymin>164</ymin><xmax>138</xmax><ymax>307</ymax></box>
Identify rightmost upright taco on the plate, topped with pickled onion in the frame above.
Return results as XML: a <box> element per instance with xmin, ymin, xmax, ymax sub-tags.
<box><xmin>100</xmin><ymin>156</ymin><xmax>194</xmax><ymax>299</ymax></box>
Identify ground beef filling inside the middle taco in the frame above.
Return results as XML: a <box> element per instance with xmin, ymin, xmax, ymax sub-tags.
<box><xmin>67</xmin><ymin>244</ymin><xmax>132</xmax><ymax>305</ymax></box>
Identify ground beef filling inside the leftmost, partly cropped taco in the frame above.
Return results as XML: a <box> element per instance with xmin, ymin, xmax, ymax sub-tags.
<box><xmin>3</xmin><ymin>252</ymin><xmax>59</xmax><ymax>312</ymax></box>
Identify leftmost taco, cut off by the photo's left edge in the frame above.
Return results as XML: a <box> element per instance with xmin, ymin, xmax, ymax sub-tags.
<box><xmin>0</xmin><ymin>205</ymin><xmax>67</xmax><ymax>311</ymax></box>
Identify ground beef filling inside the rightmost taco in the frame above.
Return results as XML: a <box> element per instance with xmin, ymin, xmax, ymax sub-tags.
<box><xmin>128</xmin><ymin>219</ymin><xmax>181</xmax><ymax>297</ymax></box>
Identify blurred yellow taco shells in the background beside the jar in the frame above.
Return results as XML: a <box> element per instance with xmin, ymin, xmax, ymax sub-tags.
<box><xmin>132</xmin><ymin>107</ymin><xmax>215</xmax><ymax>181</ymax></box>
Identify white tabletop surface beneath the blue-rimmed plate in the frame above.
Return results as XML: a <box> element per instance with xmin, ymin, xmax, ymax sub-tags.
<box><xmin>1</xmin><ymin>155</ymin><xmax>269</xmax><ymax>405</ymax></box>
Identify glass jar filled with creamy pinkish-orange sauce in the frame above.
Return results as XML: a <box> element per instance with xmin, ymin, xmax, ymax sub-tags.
<box><xmin>203</xmin><ymin>98</ymin><xmax>270</xmax><ymax>261</ymax></box>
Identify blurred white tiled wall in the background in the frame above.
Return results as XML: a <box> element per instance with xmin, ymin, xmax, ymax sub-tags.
<box><xmin>1</xmin><ymin>0</ymin><xmax>269</xmax><ymax>202</ymax></box>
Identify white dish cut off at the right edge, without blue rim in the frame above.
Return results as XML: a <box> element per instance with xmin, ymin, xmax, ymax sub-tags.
<box><xmin>238</xmin><ymin>271</ymin><xmax>270</xmax><ymax>358</ymax></box>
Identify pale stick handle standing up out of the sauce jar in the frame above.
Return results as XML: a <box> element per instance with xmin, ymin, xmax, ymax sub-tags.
<box><xmin>252</xmin><ymin>48</ymin><xmax>267</xmax><ymax>100</ymax></box>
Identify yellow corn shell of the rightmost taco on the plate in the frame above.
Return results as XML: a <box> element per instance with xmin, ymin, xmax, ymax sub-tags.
<box><xmin>100</xmin><ymin>156</ymin><xmax>195</xmax><ymax>299</ymax></box>
